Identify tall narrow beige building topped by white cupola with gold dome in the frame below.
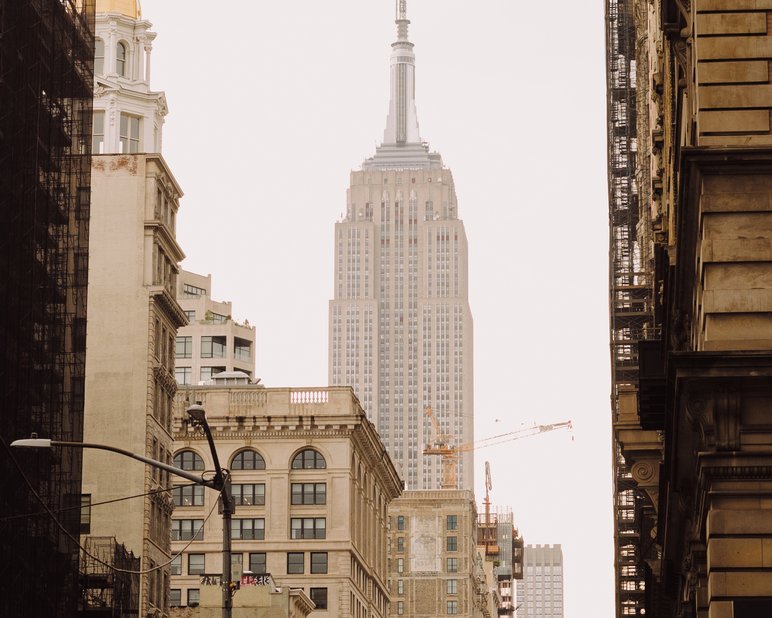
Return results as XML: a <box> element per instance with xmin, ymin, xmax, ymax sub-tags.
<box><xmin>83</xmin><ymin>0</ymin><xmax>186</xmax><ymax>617</ymax></box>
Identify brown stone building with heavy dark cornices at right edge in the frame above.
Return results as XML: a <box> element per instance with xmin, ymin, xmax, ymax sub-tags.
<box><xmin>616</xmin><ymin>0</ymin><xmax>772</xmax><ymax>618</ymax></box>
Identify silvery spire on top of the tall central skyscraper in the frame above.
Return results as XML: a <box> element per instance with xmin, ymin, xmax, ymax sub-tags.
<box><xmin>383</xmin><ymin>0</ymin><xmax>421</xmax><ymax>146</ymax></box>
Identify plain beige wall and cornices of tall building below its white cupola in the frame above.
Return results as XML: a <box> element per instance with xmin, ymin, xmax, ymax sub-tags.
<box><xmin>83</xmin><ymin>150</ymin><xmax>185</xmax><ymax>615</ymax></box>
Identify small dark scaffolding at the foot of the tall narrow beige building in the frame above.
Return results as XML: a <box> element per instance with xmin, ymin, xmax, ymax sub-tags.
<box><xmin>79</xmin><ymin>536</ymin><xmax>140</xmax><ymax>618</ymax></box>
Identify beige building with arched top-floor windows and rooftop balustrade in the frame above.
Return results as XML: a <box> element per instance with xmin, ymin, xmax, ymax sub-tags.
<box><xmin>171</xmin><ymin>380</ymin><xmax>402</xmax><ymax>618</ymax></box>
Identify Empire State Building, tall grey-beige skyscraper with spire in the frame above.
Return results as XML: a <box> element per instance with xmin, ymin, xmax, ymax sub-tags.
<box><xmin>329</xmin><ymin>0</ymin><xmax>474</xmax><ymax>489</ymax></box>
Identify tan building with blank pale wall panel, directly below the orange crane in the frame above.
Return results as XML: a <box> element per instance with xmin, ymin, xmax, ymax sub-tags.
<box><xmin>389</xmin><ymin>489</ymin><xmax>488</xmax><ymax>618</ymax></box>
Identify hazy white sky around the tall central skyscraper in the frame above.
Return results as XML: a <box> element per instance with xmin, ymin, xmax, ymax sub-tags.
<box><xmin>142</xmin><ymin>0</ymin><xmax>614</xmax><ymax>618</ymax></box>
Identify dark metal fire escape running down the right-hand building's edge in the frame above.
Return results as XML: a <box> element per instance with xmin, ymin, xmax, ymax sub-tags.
<box><xmin>606</xmin><ymin>0</ymin><xmax>656</xmax><ymax>617</ymax></box>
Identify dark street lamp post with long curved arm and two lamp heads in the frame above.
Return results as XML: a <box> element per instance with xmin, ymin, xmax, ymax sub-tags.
<box><xmin>11</xmin><ymin>403</ymin><xmax>236</xmax><ymax>618</ymax></box>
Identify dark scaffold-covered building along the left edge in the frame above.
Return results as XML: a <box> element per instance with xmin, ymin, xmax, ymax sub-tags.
<box><xmin>0</xmin><ymin>0</ymin><xmax>94</xmax><ymax>616</ymax></box>
